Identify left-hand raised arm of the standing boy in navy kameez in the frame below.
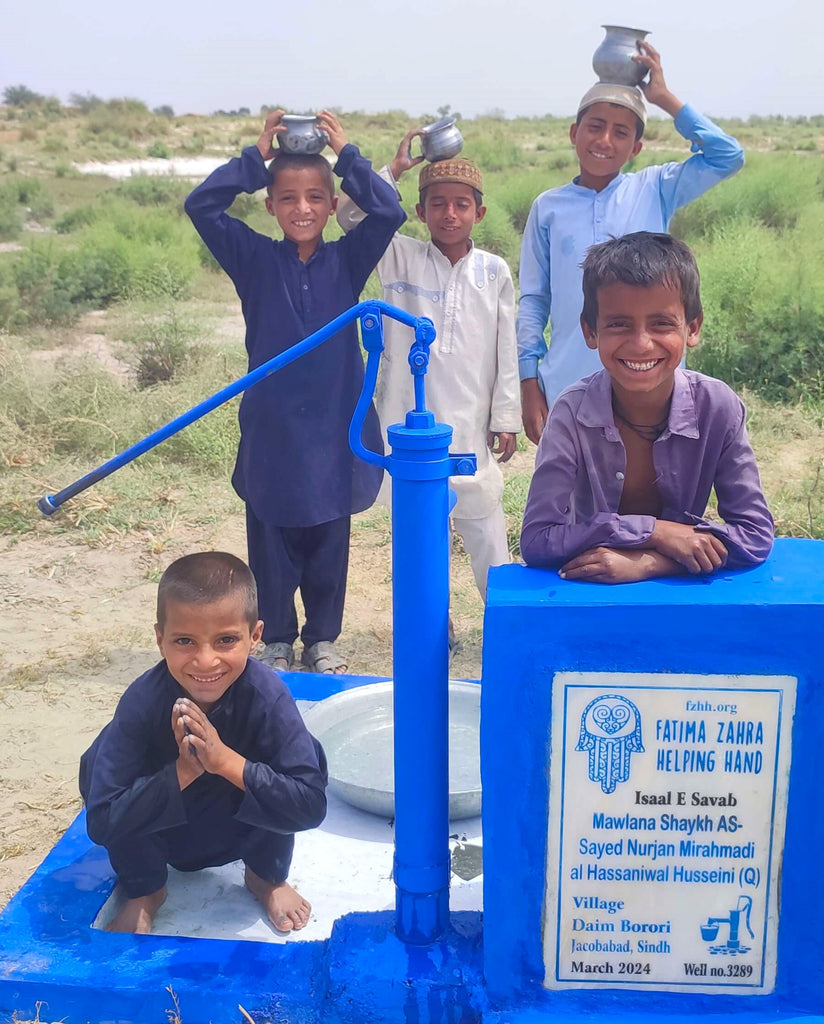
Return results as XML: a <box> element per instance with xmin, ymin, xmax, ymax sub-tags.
<box><xmin>184</xmin><ymin>111</ymin><xmax>284</xmax><ymax>285</ymax></box>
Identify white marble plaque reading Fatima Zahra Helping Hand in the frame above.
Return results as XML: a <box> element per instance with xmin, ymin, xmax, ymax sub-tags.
<box><xmin>544</xmin><ymin>673</ymin><xmax>795</xmax><ymax>995</ymax></box>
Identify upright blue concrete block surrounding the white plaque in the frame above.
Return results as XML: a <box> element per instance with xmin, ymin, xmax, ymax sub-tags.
<box><xmin>481</xmin><ymin>539</ymin><xmax>824</xmax><ymax>1022</ymax></box>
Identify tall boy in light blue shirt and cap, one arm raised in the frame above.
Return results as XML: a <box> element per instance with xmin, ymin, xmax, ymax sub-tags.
<box><xmin>517</xmin><ymin>43</ymin><xmax>744</xmax><ymax>444</ymax></box>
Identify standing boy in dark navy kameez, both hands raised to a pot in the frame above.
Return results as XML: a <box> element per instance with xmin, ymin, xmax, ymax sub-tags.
<box><xmin>185</xmin><ymin>111</ymin><xmax>405</xmax><ymax>672</ymax></box>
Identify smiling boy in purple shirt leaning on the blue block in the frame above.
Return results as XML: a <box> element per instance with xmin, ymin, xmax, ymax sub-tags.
<box><xmin>521</xmin><ymin>231</ymin><xmax>773</xmax><ymax>583</ymax></box>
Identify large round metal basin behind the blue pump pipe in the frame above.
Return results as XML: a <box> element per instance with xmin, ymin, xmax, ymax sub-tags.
<box><xmin>303</xmin><ymin>681</ymin><xmax>481</xmax><ymax>821</ymax></box>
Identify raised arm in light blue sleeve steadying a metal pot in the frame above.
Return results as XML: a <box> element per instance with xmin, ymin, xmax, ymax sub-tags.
<box><xmin>633</xmin><ymin>43</ymin><xmax>744</xmax><ymax>224</ymax></box>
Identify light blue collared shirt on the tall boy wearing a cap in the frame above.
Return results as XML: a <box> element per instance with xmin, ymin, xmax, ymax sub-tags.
<box><xmin>517</xmin><ymin>104</ymin><xmax>744</xmax><ymax>404</ymax></box>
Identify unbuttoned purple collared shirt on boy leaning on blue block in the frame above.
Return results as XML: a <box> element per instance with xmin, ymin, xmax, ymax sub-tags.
<box><xmin>521</xmin><ymin>370</ymin><xmax>773</xmax><ymax>567</ymax></box>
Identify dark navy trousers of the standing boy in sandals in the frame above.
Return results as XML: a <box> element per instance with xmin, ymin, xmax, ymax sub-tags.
<box><xmin>246</xmin><ymin>505</ymin><xmax>351</xmax><ymax>647</ymax></box>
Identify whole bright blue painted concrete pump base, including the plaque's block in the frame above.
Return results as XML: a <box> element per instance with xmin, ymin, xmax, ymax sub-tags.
<box><xmin>0</xmin><ymin>541</ymin><xmax>824</xmax><ymax>1024</ymax></box>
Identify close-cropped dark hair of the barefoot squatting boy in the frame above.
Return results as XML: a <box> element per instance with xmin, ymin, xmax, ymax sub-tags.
<box><xmin>158</xmin><ymin>551</ymin><xmax>258</xmax><ymax>629</ymax></box>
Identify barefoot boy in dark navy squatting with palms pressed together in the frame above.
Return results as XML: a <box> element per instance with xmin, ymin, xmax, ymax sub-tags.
<box><xmin>80</xmin><ymin>551</ymin><xmax>327</xmax><ymax>933</ymax></box>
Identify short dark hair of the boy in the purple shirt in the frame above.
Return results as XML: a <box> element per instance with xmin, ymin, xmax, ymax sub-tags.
<box><xmin>581</xmin><ymin>231</ymin><xmax>702</xmax><ymax>331</ymax></box>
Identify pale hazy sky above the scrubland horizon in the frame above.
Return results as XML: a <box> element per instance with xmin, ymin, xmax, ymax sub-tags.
<box><xmin>6</xmin><ymin>0</ymin><xmax>824</xmax><ymax>117</ymax></box>
